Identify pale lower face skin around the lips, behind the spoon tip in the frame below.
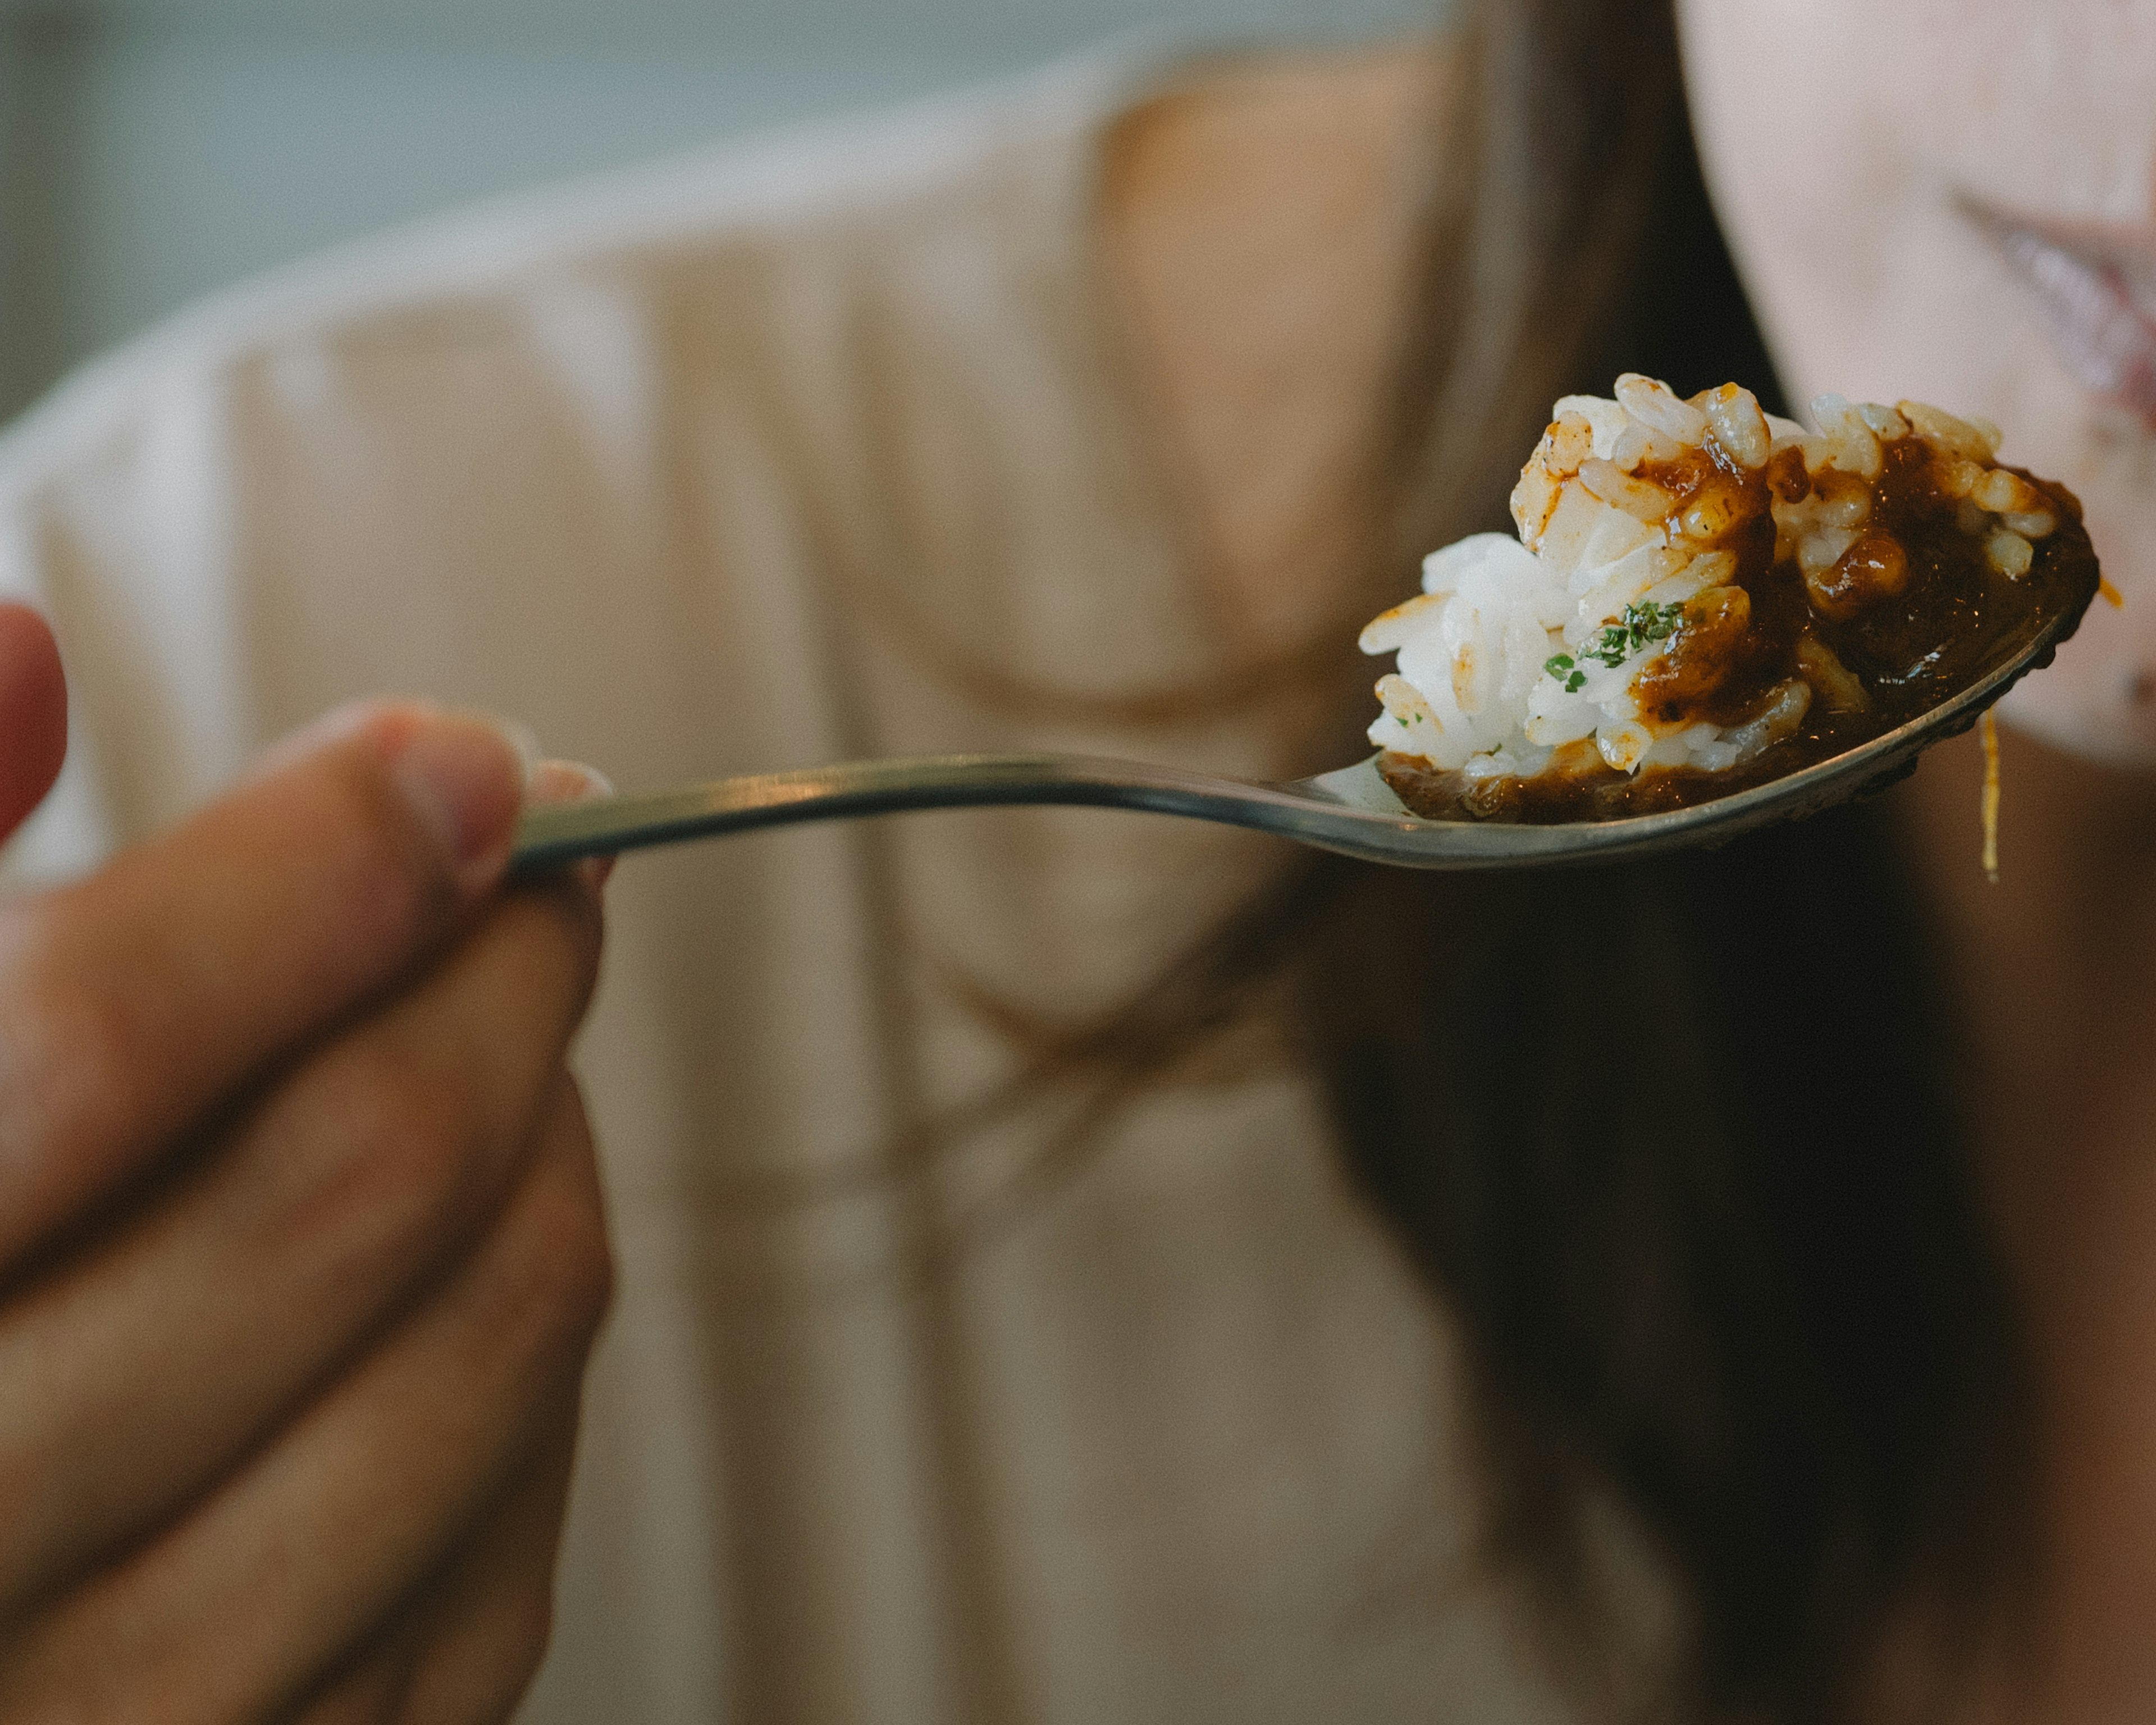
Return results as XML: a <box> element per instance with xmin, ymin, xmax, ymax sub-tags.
<box><xmin>1679</xmin><ymin>0</ymin><xmax>2156</xmax><ymax>768</ymax></box>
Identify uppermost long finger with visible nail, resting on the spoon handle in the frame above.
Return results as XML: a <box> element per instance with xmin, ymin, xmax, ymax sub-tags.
<box><xmin>0</xmin><ymin>705</ymin><xmax>522</xmax><ymax>1266</ymax></box>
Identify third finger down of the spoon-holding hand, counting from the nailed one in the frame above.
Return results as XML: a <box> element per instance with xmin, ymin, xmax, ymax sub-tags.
<box><xmin>0</xmin><ymin>1078</ymin><xmax>610</xmax><ymax>1725</ymax></box>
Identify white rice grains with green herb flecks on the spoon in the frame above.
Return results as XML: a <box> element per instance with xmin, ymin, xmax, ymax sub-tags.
<box><xmin>1360</xmin><ymin>375</ymin><xmax>2050</xmax><ymax>783</ymax></box>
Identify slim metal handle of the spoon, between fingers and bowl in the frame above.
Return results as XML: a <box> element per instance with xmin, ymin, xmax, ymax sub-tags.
<box><xmin>511</xmin><ymin>755</ymin><xmax>1336</xmax><ymax>871</ymax></box>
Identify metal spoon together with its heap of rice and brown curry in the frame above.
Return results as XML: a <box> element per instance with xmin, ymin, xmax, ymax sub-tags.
<box><xmin>515</xmin><ymin>386</ymin><xmax>2117</xmax><ymax>871</ymax></box>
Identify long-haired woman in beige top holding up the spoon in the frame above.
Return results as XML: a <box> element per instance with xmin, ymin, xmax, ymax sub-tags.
<box><xmin>0</xmin><ymin>0</ymin><xmax>2156</xmax><ymax>1721</ymax></box>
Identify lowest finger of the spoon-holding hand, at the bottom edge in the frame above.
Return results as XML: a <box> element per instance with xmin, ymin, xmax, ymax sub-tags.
<box><xmin>293</xmin><ymin>1402</ymin><xmax>578</xmax><ymax>1725</ymax></box>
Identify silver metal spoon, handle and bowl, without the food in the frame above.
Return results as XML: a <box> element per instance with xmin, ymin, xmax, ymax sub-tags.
<box><xmin>513</xmin><ymin>610</ymin><xmax>2081</xmax><ymax>871</ymax></box>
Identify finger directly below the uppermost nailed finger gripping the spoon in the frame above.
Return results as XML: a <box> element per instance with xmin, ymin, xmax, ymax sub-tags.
<box><xmin>0</xmin><ymin>880</ymin><xmax>600</xmax><ymax>1610</ymax></box>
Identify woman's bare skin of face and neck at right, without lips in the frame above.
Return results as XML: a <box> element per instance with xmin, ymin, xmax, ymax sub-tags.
<box><xmin>1679</xmin><ymin>0</ymin><xmax>2156</xmax><ymax>1721</ymax></box>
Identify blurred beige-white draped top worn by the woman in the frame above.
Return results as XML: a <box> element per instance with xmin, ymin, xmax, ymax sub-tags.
<box><xmin>0</xmin><ymin>61</ymin><xmax>1587</xmax><ymax>1725</ymax></box>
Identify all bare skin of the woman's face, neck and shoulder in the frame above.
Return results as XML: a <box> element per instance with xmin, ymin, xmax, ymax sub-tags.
<box><xmin>1102</xmin><ymin>17</ymin><xmax>2156</xmax><ymax>1725</ymax></box>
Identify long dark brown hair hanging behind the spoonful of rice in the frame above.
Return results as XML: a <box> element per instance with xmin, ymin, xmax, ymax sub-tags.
<box><xmin>1298</xmin><ymin>0</ymin><xmax>2027</xmax><ymax>1721</ymax></box>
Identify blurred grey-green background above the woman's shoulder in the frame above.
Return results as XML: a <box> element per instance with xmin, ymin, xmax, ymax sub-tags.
<box><xmin>0</xmin><ymin>0</ymin><xmax>1432</xmax><ymax>421</ymax></box>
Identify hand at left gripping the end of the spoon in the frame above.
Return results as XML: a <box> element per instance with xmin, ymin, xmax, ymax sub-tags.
<box><xmin>0</xmin><ymin>606</ymin><xmax>610</xmax><ymax>1725</ymax></box>
